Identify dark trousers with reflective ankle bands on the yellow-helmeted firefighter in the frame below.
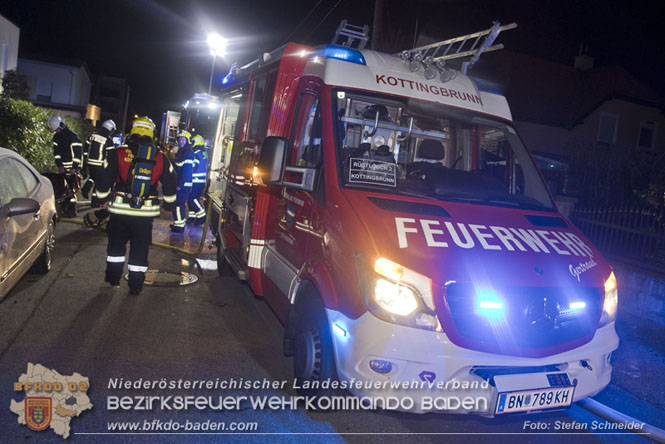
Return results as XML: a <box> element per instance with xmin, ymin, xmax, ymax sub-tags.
<box><xmin>106</xmin><ymin>214</ymin><xmax>153</xmax><ymax>293</ymax></box>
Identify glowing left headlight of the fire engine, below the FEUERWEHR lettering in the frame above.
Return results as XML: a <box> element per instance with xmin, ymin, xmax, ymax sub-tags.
<box><xmin>356</xmin><ymin>254</ymin><xmax>441</xmax><ymax>331</ymax></box>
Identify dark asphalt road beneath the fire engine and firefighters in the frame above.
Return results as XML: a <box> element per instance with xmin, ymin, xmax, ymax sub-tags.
<box><xmin>0</xmin><ymin>223</ymin><xmax>665</xmax><ymax>444</ymax></box>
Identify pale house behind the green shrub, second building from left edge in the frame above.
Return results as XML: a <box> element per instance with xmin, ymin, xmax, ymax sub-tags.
<box><xmin>18</xmin><ymin>57</ymin><xmax>92</xmax><ymax>118</ymax></box>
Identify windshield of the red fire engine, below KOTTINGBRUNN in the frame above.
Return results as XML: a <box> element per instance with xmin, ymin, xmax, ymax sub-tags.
<box><xmin>333</xmin><ymin>90</ymin><xmax>554</xmax><ymax>211</ymax></box>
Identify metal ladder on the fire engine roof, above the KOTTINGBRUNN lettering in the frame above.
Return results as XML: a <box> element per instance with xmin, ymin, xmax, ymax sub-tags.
<box><xmin>395</xmin><ymin>22</ymin><xmax>517</xmax><ymax>74</ymax></box>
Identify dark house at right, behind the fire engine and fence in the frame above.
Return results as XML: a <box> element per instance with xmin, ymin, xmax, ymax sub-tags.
<box><xmin>472</xmin><ymin>51</ymin><xmax>665</xmax><ymax>208</ymax></box>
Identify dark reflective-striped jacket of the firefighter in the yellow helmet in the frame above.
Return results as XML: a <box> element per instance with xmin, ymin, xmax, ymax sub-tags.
<box><xmin>97</xmin><ymin>142</ymin><xmax>176</xmax><ymax>217</ymax></box>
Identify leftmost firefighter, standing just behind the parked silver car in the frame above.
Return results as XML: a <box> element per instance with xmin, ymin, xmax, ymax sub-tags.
<box><xmin>46</xmin><ymin>114</ymin><xmax>83</xmax><ymax>217</ymax></box>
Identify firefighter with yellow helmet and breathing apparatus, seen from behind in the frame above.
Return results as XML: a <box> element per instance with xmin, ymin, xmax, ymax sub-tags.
<box><xmin>97</xmin><ymin>117</ymin><xmax>176</xmax><ymax>295</ymax></box>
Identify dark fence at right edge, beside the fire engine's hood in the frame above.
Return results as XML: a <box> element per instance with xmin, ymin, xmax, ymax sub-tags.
<box><xmin>570</xmin><ymin>206</ymin><xmax>665</xmax><ymax>274</ymax></box>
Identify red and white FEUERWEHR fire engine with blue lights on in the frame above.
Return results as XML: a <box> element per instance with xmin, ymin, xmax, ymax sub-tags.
<box><xmin>209</xmin><ymin>24</ymin><xmax>618</xmax><ymax>416</ymax></box>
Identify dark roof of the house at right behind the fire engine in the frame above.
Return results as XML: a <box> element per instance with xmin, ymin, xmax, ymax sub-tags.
<box><xmin>471</xmin><ymin>51</ymin><xmax>665</xmax><ymax>128</ymax></box>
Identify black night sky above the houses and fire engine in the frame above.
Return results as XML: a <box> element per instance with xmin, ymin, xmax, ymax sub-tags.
<box><xmin>0</xmin><ymin>0</ymin><xmax>665</xmax><ymax>120</ymax></box>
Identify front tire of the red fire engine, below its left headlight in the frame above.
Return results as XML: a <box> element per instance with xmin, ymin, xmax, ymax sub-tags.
<box><xmin>293</xmin><ymin>295</ymin><xmax>338</xmax><ymax>396</ymax></box>
